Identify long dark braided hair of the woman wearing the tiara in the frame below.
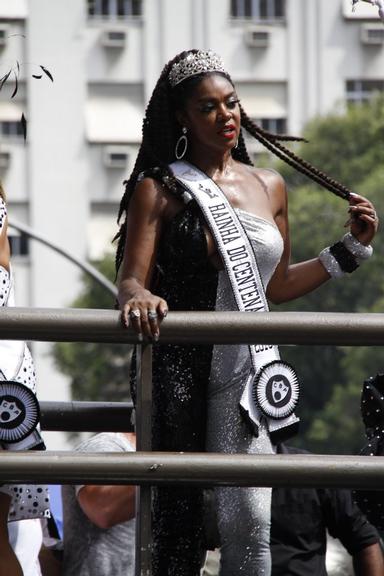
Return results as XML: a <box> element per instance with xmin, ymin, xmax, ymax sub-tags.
<box><xmin>115</xmin><ymin>49</ymin><xmax>351</xmax><ymax>270</ymax></box>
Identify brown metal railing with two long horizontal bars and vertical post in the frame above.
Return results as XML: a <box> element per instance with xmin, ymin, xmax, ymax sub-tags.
<box><xmin>0</xmin><ymin>308</ymin><xmax>384</xmax><ymax>576</ymax></box>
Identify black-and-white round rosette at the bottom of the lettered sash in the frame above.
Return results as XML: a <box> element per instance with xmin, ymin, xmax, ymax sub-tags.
<box><xmin>253</xmin><ymin>360</ymin><xmax>299</xmax><ymax>419</ymax></box>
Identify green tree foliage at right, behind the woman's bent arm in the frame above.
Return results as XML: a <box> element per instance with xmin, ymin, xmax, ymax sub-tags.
<box><xmin>274</xmin><ymin>97</ymin><xmax>384</xmax><ymax>453</ymax></box>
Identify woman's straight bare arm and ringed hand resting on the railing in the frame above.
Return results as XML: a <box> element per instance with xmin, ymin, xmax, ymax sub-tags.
<box><xmin>118</xmin><ymin>178</ymin><xmax>169</xmax><ymax>339</ymax></box>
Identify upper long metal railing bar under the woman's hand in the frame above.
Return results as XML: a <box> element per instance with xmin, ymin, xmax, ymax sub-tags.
<box><xmin>0</xmin><ymin>308</ymin><xmax>384</xmax><ymax>346</ymax></box>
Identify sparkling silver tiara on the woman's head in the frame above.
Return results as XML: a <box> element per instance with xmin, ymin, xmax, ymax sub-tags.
<box><xmin>168</xmin><ymin>50</ymin><xmax>226</xmax><ymax>88</ymax></box>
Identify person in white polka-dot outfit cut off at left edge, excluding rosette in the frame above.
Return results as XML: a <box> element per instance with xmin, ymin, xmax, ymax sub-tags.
<box><xmin>0</xmin><ymin>184</ymin><xmax>49</xmax><ymax>576</ymax></box>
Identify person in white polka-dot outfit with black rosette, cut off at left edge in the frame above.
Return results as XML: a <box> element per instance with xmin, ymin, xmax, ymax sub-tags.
<box><xmin>0</xmin><ymin>184</ymin><xmax>50</xmax><ymax>576</ymax></box>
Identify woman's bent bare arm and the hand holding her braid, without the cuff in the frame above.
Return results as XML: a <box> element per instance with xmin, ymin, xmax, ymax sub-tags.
<box><xmin>267</xmin><ymin>174</ymin><xmax>377</xmax><ymax>304</ymax></box>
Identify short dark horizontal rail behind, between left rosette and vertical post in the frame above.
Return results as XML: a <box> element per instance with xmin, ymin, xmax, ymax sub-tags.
<box><xmin>40</xmin><ymin>401</ymin><xmax>133</xmax><ymax>432</ymax></box>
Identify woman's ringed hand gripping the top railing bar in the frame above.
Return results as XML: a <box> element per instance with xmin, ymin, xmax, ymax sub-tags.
<box><xmin>119</xmin><ymin>288</ymin><xmax>168</xmax><ymax>341</ymax></box>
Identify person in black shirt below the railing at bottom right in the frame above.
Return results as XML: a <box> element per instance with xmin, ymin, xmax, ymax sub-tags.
<box><xmin>271</xmin><ymin>444</ymin><xmax>384</xmax><ymax>576</ymax></box>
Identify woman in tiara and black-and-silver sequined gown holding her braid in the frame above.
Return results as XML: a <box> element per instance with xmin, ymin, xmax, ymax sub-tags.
<box><xmin>117</xmin><ymin>51</ymin><xmax>377</xmax><ymax>576</ymax></box>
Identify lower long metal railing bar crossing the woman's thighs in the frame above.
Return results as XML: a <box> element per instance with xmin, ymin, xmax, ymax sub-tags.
<box><xmin>0</xmin><ymin>452</ymin><xmax>384</xmax><ymax>490</ymax></box>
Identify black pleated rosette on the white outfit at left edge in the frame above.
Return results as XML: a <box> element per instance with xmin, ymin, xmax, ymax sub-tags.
<box><xmin>0</xmin><ymin>380</ymin><xmax>40</xmax><ymax>444</ymax></box>
